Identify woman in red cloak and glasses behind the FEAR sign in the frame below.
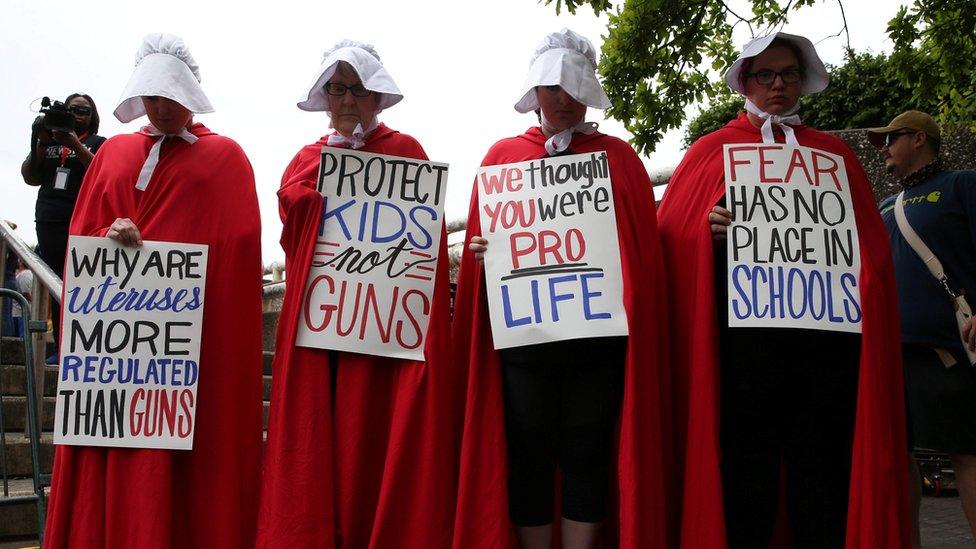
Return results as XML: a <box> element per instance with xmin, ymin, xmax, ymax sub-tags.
<box><xmin>660</xmin><ymin>33</ymin><xmax>909</xmax><ymax>549</ymax></box>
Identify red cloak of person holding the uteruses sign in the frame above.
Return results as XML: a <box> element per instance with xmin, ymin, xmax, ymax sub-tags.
<box><xmin>44</xmin><ymin>124</ymin><xmax>261</xmax><ymax>549</ymax></box>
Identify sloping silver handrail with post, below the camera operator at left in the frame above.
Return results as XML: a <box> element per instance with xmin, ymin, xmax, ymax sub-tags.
<box><xmin>0</xmin><ymin>219</ymin><xmax>63</xmax><ymax>436</ymax></box>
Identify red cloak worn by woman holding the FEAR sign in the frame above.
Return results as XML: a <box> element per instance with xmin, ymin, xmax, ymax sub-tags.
<box><xmin>660</xmin><ymin>113</ymin><xmax>910</xmax><ymax>549</ymax></box>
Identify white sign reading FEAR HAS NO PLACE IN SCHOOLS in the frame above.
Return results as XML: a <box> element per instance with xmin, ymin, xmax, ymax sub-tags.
<box><xmin>723</xmin><ymin>143</ymin><xmax>861</xmax><ymax>333</ymax></box>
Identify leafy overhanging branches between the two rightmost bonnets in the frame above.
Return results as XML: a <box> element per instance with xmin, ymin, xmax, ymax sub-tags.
<box><xmin>544</xmin><ymin>0</ymin><xmax>816</xmax><ymax>154</ymax></box>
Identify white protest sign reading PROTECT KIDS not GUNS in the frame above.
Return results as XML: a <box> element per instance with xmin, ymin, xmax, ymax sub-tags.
<box><xmin>296</xmin><ymin>147</ymin><xmax>447</xmax><ymax>360</ymax></box>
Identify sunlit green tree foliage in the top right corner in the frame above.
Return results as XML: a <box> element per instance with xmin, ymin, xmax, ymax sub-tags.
<box><xmin>888</xmin><ymin>0</ymin><xmax>976</xmax><ymax>129</ymax></box>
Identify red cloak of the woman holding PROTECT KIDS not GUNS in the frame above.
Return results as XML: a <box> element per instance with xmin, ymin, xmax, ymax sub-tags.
<box><xmin>258</xmin><ymin>124</ymin><xmax>461</xmax><ymax>549</ymax></box>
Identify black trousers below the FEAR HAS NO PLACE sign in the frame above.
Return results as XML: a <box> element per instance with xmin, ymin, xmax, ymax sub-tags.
<box><xmin>721</xmin><ymin>328</ymin><xmax>860</xmax><ymax>549</ymax></box>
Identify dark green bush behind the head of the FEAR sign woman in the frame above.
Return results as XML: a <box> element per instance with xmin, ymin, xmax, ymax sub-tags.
<box><xmin>685</xmin><ymin>51</ymin><xmax>938</xmax><ymax>146</ymax></box>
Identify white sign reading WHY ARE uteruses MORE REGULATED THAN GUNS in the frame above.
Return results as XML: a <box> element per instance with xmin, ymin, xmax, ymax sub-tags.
<box><xmin>54</xmin><ymin>236</ymin><xmax>208</xmax><ymax>450</ymax></box>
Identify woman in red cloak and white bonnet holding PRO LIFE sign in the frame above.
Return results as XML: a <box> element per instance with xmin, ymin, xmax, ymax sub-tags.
<box><xmin>454</xmin><ymin>29</ymin><xmax>672</xmax><ymax>549</ymax></box>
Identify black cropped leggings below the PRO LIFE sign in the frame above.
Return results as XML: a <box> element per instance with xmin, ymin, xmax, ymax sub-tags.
<box><xmin>500</xmin><ymin>338</ymin><xmax>627</xmax><ymax>526</ymax></box>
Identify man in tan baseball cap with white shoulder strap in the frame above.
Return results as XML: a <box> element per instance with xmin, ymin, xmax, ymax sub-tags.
<box><xmin>867</xmin><ymin>111</ymin><xmax>976</xmax><ymax>539</ymax></box>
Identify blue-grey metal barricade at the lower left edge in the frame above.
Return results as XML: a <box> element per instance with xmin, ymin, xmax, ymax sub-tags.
<box><xmin>0</xmin><ymin>288</ymin><xmax>51</xmax><ymax>547</ymax></box>
